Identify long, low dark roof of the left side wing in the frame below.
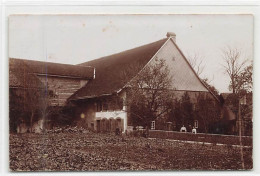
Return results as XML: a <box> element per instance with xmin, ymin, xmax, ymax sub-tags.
<box><xmin>10</xmin><ymin>58</ymin><xmax>94</xmax><ymax>79</ymax></box>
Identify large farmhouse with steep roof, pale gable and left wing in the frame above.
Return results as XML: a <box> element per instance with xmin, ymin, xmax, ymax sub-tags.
<box><xmin>9</xmin><ymin>33</ymin><xmax>218</xmax><ymax>132</ymax></box>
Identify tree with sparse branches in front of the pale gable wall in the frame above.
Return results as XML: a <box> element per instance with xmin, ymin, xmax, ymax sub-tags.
<box><xmin>122</xmin><ymin>59</ymin><xmax>173</xmax><ymax>126</ymax></box>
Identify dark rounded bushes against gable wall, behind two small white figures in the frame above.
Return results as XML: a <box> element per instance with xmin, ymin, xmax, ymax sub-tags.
<box><xmin>169</xmin><ymin>92</ymin><xmax>220</xmax><ymax>133</ymax></box>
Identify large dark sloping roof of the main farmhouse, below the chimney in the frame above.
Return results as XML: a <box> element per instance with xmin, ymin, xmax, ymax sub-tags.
<box><xmin>70</xmin><ymin>38</ymin><xmax>168</xmax><ymax>100</ymax></box>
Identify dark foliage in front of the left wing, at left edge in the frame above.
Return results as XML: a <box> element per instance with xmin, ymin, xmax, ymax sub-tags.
<box><xmin>9</xmin><ymin>88</ymin><xmax>64</xmax><ymax>132</ymax></box>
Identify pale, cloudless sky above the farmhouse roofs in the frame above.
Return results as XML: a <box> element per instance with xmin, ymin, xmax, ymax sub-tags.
<box><xmin>8</xmin><ymin>15</ymin><xmax>254</xmax><ymax>93</ymax></box>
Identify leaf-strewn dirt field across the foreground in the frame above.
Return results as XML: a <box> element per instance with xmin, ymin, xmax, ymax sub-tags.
<box><xmin>10</xmin><ymin>132</ymin><xmax>253</xmax><ymax>171</ymax></box>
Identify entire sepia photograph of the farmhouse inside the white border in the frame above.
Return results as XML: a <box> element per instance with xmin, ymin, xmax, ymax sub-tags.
<box><xmin>8</xmin><ymin>14</ymin><xmax>254</xmax><ymax>172</ymax></box>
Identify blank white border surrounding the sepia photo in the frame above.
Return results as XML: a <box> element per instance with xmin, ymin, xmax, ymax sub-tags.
<box><xmin>0</xmin><ymin>0</ymin><xmax>260</xmax><ymax>175</ymax></box>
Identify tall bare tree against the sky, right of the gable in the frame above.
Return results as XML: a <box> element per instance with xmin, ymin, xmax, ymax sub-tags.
<box><xmin>222</xmin><ymin>47</ymin><xmax>247</xmax><ymax>93</ymax></box>
